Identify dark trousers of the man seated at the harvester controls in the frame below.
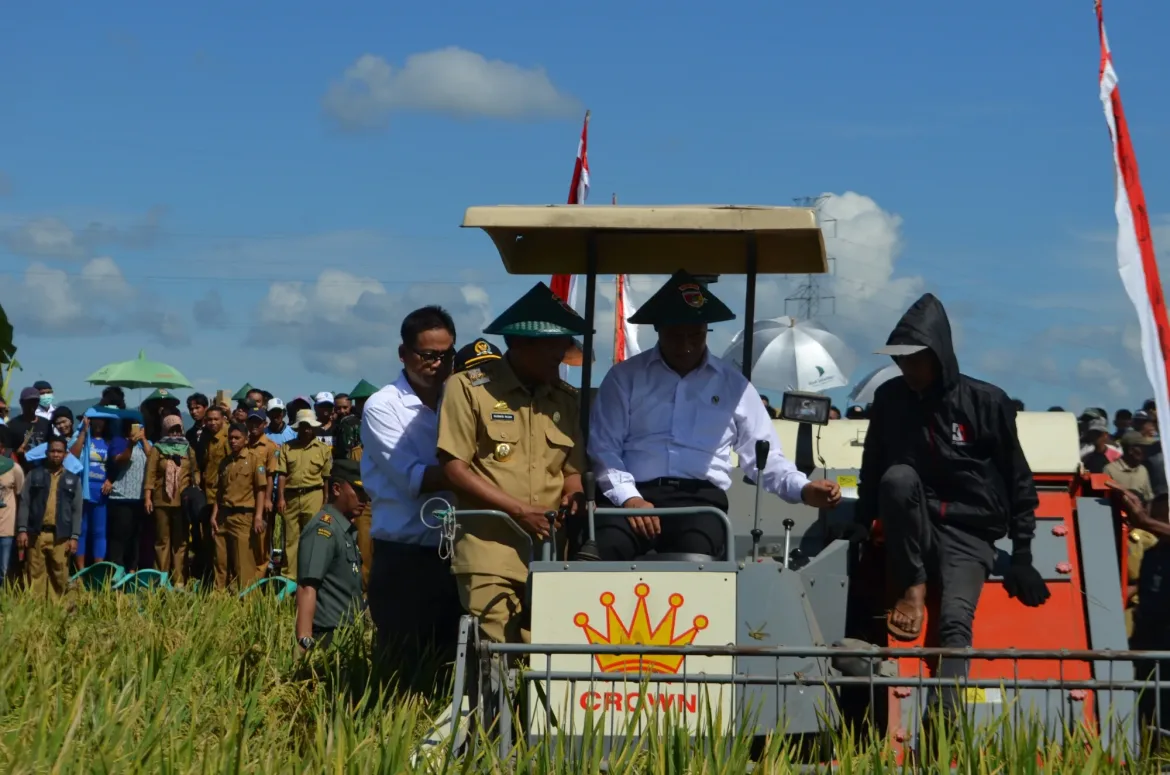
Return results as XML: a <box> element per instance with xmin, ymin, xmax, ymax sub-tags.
<box><xmin>594</xmin><ymin>479</ymin><xmax>728</xmax><ymax>562</ymax></box>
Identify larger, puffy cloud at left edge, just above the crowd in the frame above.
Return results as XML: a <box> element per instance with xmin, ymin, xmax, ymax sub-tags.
<box><xmin>0</xmin><ymin>256</ymin><xmax>190</xmax><ymax>345</ymax></box>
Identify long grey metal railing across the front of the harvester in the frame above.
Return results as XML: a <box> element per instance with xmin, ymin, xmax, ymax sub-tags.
<box><xmin>453</xmin><ymin>642</ymin><xmax>1170</xmax><ymax>755</ymax></box>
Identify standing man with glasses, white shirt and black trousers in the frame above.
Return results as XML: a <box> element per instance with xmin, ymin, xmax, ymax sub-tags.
<box><xmin>362</xmin><ymin>307</ymin><xmax>462</xmax><ymax>668</ymax></box>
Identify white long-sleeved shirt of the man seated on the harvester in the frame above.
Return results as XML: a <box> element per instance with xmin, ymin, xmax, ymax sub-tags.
<box><xmin>589</xmin><ymin>347</ymin><xmax>808</xmax><ymax>506</ymax></box>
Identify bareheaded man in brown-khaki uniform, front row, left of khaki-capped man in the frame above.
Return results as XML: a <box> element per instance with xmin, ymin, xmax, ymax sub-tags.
<box><xmin>212</xmin><ymin>425</ymin><xmax>268</xmax><ymax>589</ymax></box>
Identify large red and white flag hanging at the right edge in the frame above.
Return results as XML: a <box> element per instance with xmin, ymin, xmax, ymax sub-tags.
<box><xmin>1095</xmin><ymin>0</ymin><xmax>1170</xmax><ymax>487</ymax></box>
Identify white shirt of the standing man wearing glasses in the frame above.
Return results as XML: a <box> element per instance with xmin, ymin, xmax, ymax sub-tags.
<box><xmin>362</xmin><ymin>372</ymin><xmax>455</xmax><ymax>547</ymax></box>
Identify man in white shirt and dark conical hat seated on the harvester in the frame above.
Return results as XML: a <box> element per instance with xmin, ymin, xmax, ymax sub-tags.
<box><xmin>589</xmin><ymin>272</ymin><xmax>841</xmax><ymax>561</ymax></box>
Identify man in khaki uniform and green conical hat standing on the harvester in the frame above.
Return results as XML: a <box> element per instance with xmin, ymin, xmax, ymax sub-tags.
<box><xmin>439</xmin><ymin>283</ymin><xmax>585</xmax><ymax>643</ymax></box>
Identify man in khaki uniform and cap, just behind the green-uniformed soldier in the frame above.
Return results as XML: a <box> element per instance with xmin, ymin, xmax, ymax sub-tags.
<box><xmin>276</xmin><ymin>409</ymin><xmax>333</xmax><ymax>578</ymax></box>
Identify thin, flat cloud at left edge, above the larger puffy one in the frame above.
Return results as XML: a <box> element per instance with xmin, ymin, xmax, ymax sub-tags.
<box><xmin>0</xmin><ymin>207</ymin><xmax>166</xmax><ymax>259</ymax></box>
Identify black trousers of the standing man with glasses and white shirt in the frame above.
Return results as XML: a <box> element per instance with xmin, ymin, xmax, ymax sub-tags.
<box><xmin>366</xmin><ymin>539</ymin><xmax>463</xmax><ymax>673</ymax></box>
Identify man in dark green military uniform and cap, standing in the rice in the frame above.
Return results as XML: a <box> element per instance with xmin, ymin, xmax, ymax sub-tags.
<box><xmin>296</xmin><ymin>460</ymin><xmax>369</xmax><ymax>651</ymax></box>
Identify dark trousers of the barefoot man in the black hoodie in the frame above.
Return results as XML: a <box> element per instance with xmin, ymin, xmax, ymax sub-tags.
<box><xmin>879</xmin><ymin>466</ymin><xmax>996</xmax><ymax>709</ymax></box>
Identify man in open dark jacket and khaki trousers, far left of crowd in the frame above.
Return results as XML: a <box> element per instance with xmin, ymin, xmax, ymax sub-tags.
<box><xmin>16</xmin><ymin>438</ymin><xmax>84</xmax><ymax>598</ymax></box>
